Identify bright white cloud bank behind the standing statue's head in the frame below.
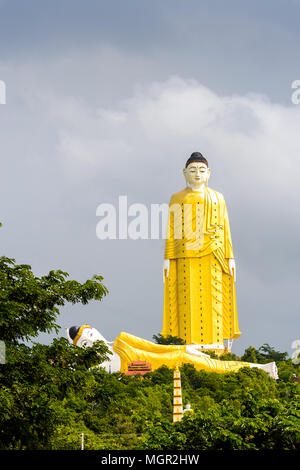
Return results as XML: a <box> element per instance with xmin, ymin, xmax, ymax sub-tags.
<box><xmin>44</xmin><ymin>72</ymin><xmax>300</xmax><ymax>197</ymax></box>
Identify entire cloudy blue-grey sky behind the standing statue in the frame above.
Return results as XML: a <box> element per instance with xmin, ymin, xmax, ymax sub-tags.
<box><xmin>0</xmin><ymin>0</ymin><xmax>300</xmax><ymax>354</ymax></box>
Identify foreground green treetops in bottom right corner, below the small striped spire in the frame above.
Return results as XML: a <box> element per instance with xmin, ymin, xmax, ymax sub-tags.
<box><xmin>142</xmin><ymin>392</ymin><xmax>300</xmax><ymax>451</ymax></box>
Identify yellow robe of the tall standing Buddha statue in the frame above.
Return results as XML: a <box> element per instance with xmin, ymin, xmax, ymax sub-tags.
<box><xmin>161</xmin><ymin>187</ymin><xmax>240</xmax><ymax>352</ymax></box>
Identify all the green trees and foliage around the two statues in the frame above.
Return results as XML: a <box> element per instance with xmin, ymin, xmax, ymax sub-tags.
<box><xmin>0</xmin><ymin>258</ymin><xmax>300</xmax><ymax>450</ymax></box>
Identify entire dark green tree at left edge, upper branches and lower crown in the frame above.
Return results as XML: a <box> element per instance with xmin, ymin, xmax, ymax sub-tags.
<box><xmin>0</xmin><ymin>252</ymin><xmax>108</xmax><ymax>449</ymax></box>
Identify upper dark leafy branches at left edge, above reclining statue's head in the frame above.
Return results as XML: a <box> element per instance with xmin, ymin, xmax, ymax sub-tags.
<box><xmin>0</xmin><ymin>256</ymin><xmax>108</xmax><ymax>344</ymax></box>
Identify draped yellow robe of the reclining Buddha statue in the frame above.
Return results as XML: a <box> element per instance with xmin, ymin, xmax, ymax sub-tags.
<box><xmin>113</xmin><ymin>332</ymin><xmax>250</xmax><ymax>373</ymax></box>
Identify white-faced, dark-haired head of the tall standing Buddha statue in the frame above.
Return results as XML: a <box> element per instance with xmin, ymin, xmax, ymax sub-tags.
<box><xmin>183</xmin><ymin>152</ymin><xmax>210</xmax><ymax>189</ymax></box>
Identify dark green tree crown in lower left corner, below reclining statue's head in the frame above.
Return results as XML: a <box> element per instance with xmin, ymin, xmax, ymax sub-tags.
<box><xmin>0</xmin><ymin>338</ymin><xmax>108</xmax><ymax>449</ymax></box>
